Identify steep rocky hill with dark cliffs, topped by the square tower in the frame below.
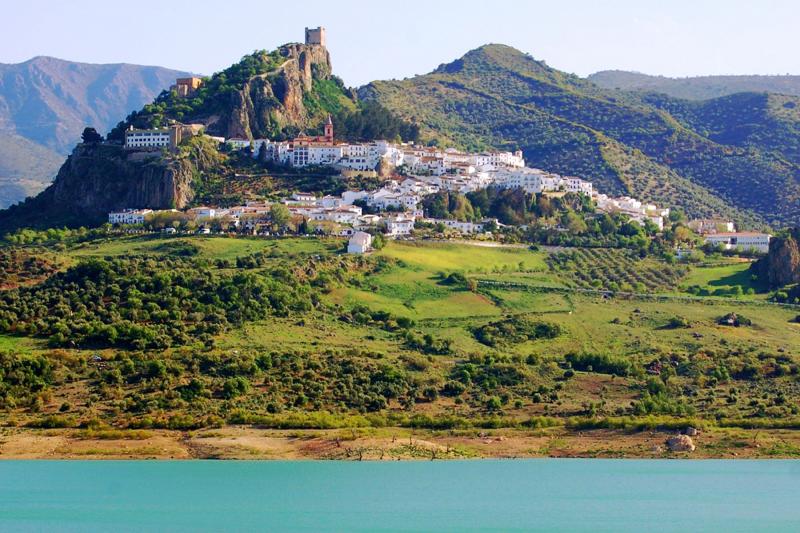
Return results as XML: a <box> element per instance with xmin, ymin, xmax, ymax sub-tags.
<box><xmin>0</xmin><ymin>39</ymin><xmax>416</xmax><ymax>227</ymax></box>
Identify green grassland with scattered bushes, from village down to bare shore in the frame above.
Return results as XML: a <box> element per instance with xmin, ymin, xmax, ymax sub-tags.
<box><xmin>0</xmin><ymin>236</ymin><xmax>800</xmax><ymax>434</ymax></box>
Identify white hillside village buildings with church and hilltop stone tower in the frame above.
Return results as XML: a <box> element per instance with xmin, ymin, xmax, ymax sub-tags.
<box><xmin>108</xmin><ymin>27</ymin><xmax>770</xmax><ymax>253</ymax></box>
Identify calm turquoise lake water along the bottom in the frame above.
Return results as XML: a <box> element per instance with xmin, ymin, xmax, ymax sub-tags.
<box><xmin>0</xmin><ymin>459</ymin><xmax>800</xmax><ymax>533</ymax></box>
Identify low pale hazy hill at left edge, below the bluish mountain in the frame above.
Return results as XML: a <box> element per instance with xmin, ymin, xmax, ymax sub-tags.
<box><xmin>0</xmin><ymin>131</ymin><xmax>64</xmax><ymax>209</ymax></box>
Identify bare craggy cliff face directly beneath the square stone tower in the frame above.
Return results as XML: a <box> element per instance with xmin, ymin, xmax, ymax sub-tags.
<box><xmin>216</xmin><ymin>44</ymin><xmax>332</xmax><ymax>138</ymax></box>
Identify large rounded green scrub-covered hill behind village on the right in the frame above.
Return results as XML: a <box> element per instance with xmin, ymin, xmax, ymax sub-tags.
<box><xmin>359</xmin><ymin>44</ymin><xmax>800</xmax><ymax>227</ymax></box>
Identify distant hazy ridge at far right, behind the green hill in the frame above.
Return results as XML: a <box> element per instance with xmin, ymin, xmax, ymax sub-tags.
<box><xmin>588</xmin><ymin>70</ymin><xmax>800</xmax><ymax>100</ymax></box>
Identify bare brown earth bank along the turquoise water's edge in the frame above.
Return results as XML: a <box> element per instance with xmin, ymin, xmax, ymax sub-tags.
<box><xmin>0</xmin><ymin>426</ymin><xmax>800</xmax><ymax>461</ymax></box>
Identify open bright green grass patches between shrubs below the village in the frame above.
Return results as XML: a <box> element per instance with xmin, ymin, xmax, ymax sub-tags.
<box><xmin>0</xmin><ymin>237</ymin><xmax>800</xmax><ymax>434</ymax></box>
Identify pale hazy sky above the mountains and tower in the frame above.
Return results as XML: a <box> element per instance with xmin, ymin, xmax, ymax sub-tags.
<box><xmin>0</xmin><ymin>0</ymin><xmax>800</xmax><ymax>85</ymax></box>
